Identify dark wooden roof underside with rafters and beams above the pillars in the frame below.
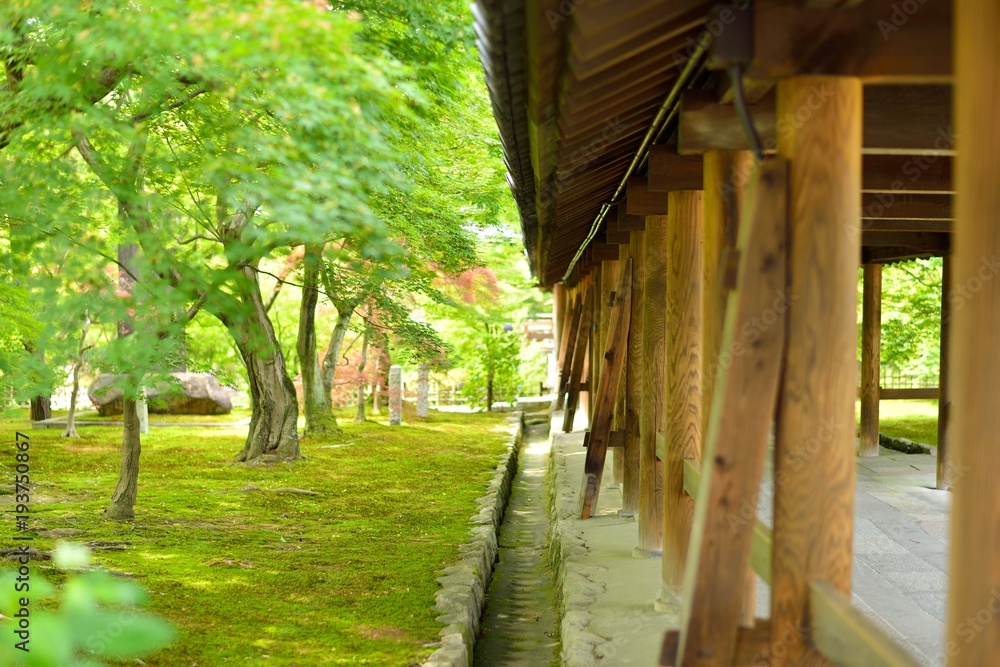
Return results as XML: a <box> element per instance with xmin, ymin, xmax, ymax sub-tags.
<box><xmin>474</xmin><ymin>0</ymin><xmax>953</xmax><ymax>285</ymax></box>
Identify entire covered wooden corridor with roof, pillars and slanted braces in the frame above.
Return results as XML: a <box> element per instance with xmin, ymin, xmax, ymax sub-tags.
<box><xmin>475</xmin><ymin>0</ymin><xmax>1000</xmax><ymax>666</ymax></box>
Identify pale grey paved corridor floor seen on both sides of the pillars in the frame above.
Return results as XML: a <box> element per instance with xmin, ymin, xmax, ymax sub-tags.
<box><xmin>550</xmin><ymin>415</ymin><xmax>951</xmax><ymax>666</ymax></box>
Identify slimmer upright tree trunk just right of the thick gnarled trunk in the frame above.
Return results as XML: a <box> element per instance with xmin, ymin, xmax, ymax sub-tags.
<box><xmin>296</xmin><ymin>244</ymin><xmax>343</xmax><ymax>437</ymax></box>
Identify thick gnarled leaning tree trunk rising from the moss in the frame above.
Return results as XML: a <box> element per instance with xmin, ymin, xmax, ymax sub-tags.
<box><xmin>224</xmin><ymin>267</ymin><xmax>299</xmax><ymax>462</ymax></box>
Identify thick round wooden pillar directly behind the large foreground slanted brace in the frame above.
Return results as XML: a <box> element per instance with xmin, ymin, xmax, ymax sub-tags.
<box><xmin>771</xmin><ymin>77</ymin><xmax>862</xmax><ymax>666</ymax></box>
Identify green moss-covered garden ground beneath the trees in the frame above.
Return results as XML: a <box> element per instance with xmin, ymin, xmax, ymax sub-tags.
<box><xmin>0</xmin><ymin>413</ymin><xmax>507</xmax><ymax>667</ymax></box>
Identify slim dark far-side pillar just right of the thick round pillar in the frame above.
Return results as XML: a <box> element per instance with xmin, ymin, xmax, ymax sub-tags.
<box><xmin>858</xmin><ymin>264</ymin><xmax>882</xmax><ymax>456</ymax></box>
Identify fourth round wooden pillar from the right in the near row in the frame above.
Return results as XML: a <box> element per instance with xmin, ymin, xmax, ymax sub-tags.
<box><xmin>663</xmin><ymin>190</ymin><xmax>703</xmax><ymax>599</ymax></box>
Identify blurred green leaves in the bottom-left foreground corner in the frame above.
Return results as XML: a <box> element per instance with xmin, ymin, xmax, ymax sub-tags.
<box><xmin>0</xmin><ymin>544</ymin><xmax>175</xmax><ymax>667</ymax></box>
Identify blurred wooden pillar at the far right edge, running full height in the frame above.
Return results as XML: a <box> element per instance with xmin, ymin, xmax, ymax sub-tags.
<box><xmin>945</xmin><ymin>0</ymin><xmax>1000</xmax><ymax>667</ymax></box>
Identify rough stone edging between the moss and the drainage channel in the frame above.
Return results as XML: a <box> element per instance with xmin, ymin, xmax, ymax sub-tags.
<box><xmin>424</xmin><ymin>412</ymin><xmax>524</xmax><ymax>667</ymax></box>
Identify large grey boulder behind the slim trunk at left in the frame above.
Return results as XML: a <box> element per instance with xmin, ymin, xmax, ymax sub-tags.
<box><xmin>87</xmin><ymin>373</ymin><xmax>233</xmax><ymax>416</ymax></box>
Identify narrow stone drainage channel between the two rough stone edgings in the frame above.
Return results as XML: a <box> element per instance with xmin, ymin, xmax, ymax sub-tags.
<box><xmin>473</xmin><ymin>436</ymin><xmax>559</xmax><ymax>667</ymax></box>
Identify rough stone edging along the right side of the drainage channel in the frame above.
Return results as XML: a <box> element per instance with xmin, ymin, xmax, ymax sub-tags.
<box><xmin>546</xmin><ymin>438</ymin><xmax>610</xmax><ymax>667</ymax></box>
